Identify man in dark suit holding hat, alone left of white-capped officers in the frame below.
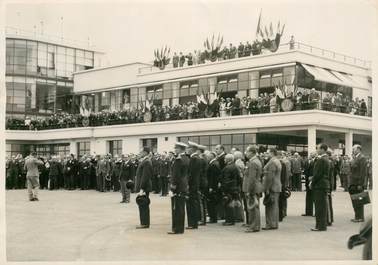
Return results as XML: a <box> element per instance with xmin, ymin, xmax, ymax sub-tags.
<box><xmin>136</xmin><ymin>147</ymin><xmax>153</xmax><ymax>229</ymax></box>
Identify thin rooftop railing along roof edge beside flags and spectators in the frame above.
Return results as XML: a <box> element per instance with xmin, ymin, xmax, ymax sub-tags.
<box><xmin>139</xmin><ymin>42</ymin><xmax>371</xmax><ymax>74</ymax></box>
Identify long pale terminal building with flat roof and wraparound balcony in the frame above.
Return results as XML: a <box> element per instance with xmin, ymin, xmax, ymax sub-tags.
<box><xmin>6</xmin><ymin>35</ymin><xmax>372</xmax><ymax>156</ymax></box>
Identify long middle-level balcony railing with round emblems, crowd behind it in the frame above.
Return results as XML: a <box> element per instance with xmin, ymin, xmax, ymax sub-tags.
<box><xmin>6</xmin><ymin>101</ymin><xmax>371</xmax><ymax>130</ymax></box>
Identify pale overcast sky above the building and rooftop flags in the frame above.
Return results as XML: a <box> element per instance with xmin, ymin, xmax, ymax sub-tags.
<box><xmin>6</xmin><ymin>0</ymin><xmax>377</xmax><ymax>65</ymax></box>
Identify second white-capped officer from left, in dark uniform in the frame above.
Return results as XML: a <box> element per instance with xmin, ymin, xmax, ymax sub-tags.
<box><xmin>186</xmin><ymin>141</ymin><xmax>201</xmax><ymax>229</ymax></box>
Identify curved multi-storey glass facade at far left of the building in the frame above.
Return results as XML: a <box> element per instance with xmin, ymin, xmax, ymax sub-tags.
<box><xmin>5</xmin><ymin>38</ymin><xmax>94</xmax><ymax>119</ymax></box>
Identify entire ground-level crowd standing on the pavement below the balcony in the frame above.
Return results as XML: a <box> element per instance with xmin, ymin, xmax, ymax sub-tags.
<box><xmin>6</xmin><ymin>142</ymin><xmax>372</xmax><ymax>234</ymax></box>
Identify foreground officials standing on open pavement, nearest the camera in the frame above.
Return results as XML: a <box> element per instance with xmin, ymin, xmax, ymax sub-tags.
<box><xmin>136</xmin><ymin>141</ymin><xmax>366</xmax><ymax>234</ymax></box>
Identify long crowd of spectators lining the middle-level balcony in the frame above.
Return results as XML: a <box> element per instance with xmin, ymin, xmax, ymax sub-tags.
<box><xmin>6</xmin><ymin>89</ymin><xmax>368</xmax><ymax>130</ymax></box>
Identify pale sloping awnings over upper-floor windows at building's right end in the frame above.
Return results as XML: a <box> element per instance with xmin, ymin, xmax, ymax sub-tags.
<box><xmin>302</xmin><ymin>64</ymin><xmax>369</xmax><ymax>89</ymax></box>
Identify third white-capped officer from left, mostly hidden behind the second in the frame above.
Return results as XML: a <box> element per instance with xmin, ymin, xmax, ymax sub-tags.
<box><xmin>197</xmin><ymin>145</ymin><xmax>208</xmax><ymax>225</ymax></box>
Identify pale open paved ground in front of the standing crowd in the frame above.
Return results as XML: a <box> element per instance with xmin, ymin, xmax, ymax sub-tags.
<box><xmin>6</xmin><ymin>190</ymin><xmax>371</xmax><ymax>261</ymax></box>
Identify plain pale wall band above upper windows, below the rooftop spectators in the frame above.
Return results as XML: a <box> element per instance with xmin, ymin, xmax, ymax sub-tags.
<box><xmin>74</xmin><ymin>50</ymin><xmax>371</xmax><ymax>93</ymax></box>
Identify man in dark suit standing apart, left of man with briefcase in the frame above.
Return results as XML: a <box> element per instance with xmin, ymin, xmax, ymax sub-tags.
<box><xmin>310</xmin><ymin>144</ymin><xmax>331</xmax><ymax>231</ymax></box>
